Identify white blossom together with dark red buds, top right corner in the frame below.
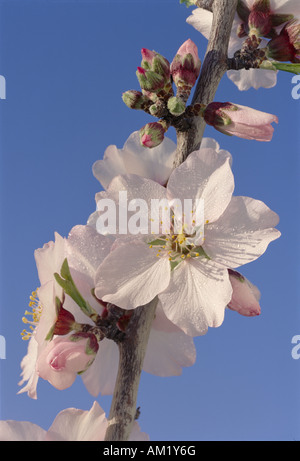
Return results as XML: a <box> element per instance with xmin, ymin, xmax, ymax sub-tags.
<box><xmin>187</xmin><ymin>0</ymin><xmax>300</xmax><ymax>91</ymax></box>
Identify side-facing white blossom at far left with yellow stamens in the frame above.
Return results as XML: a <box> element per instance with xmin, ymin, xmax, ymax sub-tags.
<box><xmin>19</xmin><ymin>226</ymin><xmax>118</xmax><ymax>399</ymax></box>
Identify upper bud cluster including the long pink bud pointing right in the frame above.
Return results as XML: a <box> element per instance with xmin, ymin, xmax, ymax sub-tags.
<box><xmin>123</xmin><ymin>38</ymin><xmax>278</xmax><ymax>145</ymax></box>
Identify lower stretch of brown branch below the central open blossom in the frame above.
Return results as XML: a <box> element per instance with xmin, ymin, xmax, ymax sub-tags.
<box><xmin>105</xmin><ymin>298</ymin><xmax>158</xmax><ymax>442</ymax></box>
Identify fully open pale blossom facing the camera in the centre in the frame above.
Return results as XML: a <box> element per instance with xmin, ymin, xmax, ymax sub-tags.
<box><xmin>89</xmin><ymin>149</ymin><xmax>280</xmax><ymax>336</ymax></box>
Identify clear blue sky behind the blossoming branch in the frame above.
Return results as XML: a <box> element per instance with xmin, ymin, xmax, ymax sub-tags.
<box><xmin>0</xmin><ymin>0</ymin><xmax>300</xmax><ymax>441</ymax></box>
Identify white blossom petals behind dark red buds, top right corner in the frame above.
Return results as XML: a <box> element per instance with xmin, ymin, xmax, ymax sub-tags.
<box><xmin>187</xmin><ymin>0</ymin><xmax>300</xmax><ymax>91</ymax></box>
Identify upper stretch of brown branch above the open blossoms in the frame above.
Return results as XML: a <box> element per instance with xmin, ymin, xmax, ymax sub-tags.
<box><xmin>173</xmin><ymin>0</ymin><xmax>237</xmax><ymax>168</ymax></box>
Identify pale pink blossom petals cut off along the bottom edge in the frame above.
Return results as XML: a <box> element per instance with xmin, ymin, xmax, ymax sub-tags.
<box><xmin>0</xmin><ymin>402</ymin><xmax>149</xmax><ymax>442</ymax></box>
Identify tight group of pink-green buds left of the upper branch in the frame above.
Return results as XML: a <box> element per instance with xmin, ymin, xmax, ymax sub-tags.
<box><xmin>123</xmin><ymin>40</ymin><xmax>201</xmax><ymax>148</ymax></box>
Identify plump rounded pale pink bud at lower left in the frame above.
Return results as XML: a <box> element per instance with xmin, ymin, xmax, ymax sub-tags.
<box><xmin>36</xmin><ymin>332</ymin><xmax>99</xmax><ymax>390</ymax></box>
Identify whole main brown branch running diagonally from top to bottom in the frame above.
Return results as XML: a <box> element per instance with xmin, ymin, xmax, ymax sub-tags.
<box><xmin>105</xmin><ymin>0</ymin><xmax>237</xmax><ymax>441</ymax></box>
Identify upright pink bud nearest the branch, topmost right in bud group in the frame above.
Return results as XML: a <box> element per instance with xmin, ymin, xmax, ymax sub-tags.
<box><xmin>171</xmin><ymin>39</ymin><xmax>201</xmax><ymax>88</ymax></box>
